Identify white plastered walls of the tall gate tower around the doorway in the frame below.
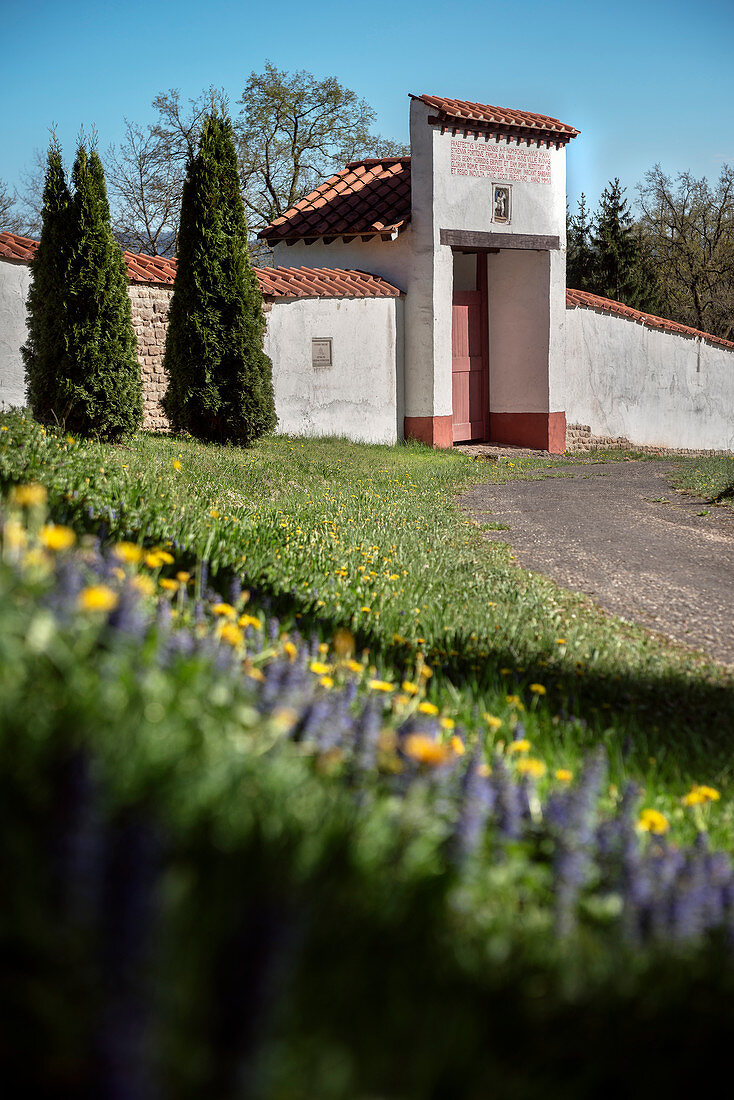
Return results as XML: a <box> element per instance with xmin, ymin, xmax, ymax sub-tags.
<box><xmin>405</xmin><ymin>100</ymin><xmax>566</xmax><ymax>416</ymax></box>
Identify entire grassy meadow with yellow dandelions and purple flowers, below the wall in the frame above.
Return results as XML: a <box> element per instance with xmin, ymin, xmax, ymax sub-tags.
<box><xmin>0</xmin><ymin>415</ymin><xmax>734</xmax><ymax>1100</ymax></box>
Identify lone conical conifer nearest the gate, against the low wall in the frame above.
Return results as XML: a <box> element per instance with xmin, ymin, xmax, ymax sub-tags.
<box><xmin>163</xmin><ymin>111</ymin><xmax>275</xmax><ymax>446</ymax></box>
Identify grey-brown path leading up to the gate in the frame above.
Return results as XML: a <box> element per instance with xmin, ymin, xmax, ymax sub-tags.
<box><xmin>461</xmin><ymin>461</ymin><xmax>734</xmax><ymax>664</ymax></box>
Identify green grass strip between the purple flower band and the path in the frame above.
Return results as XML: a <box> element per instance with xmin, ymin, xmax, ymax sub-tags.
<box><xmin>0</xmin><ymin>417</ymin><xmax>734</xmax><ymax>842</ymax></box>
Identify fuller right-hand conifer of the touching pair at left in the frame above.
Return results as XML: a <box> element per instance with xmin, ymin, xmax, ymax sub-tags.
<box><xmin>56</xmin><ymin>145</ymin><xmax>143</xmax><ymax>440</ymax></box>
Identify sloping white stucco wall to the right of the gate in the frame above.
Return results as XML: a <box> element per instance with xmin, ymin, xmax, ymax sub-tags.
<box><xmin>565</xmin><ymin>308</ymin><xmax>734</xmax><ymax>450</ymax></box>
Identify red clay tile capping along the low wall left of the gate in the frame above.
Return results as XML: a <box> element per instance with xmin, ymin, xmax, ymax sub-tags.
<box><xmin>0</xmin><ymin>233</ymin><xmax>402</xmax><ymax>298</ymax></box>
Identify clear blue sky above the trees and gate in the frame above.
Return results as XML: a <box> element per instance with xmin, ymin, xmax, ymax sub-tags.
<box><xmin>0</xmin><ymin>0</ymin><xmax>734</xmax><ymax>216</ymax></box>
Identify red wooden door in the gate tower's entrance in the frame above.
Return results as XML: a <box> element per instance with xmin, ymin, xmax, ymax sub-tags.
<box><xmin>451</xmin><ymin>271</ymin><xmax>489</xmax><ymax>443</ymax></box>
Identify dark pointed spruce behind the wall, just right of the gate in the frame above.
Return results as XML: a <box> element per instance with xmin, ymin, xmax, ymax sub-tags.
<box><xmin>580</xmin><ymin>179</ymin><xmax>657</xmax><ymax>312</ymax></box>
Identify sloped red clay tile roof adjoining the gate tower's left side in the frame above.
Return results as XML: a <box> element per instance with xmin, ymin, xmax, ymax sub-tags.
<box><xmin>258</xmin><ymin>156</ymin><xmax>410</xmax><ymax>243</ymax></box>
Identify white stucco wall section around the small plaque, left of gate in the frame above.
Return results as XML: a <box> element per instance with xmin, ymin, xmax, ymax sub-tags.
<box><xmin>265</xmin><ymin>299</ymin><xmax>403</xmax><ymax>443</ymax></box>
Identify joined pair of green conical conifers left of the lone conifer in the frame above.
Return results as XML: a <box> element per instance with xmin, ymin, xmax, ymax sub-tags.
<box><xmin>23</xmin><ymin>144</ymin><xmax>143</xmax><ymax>441</ymax></box>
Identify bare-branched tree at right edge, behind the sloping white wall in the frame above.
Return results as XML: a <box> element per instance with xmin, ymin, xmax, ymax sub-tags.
<box><xmin>637</xmin><ymin>164</ymin><xmax>734</xmax><ymax>340</ymax></box>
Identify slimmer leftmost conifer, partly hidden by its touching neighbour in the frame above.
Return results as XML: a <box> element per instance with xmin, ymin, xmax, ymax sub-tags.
<box><xmin>22</xmin><ymin>136</ymin><xmax>72</xmax><ymax>424</ymax></box>
